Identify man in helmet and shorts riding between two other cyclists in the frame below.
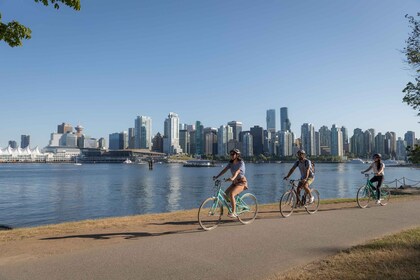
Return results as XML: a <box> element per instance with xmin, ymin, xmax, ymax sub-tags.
<box><xmin>283</xmin><ymin>150</ymin><xmax>315</xmax><ymax>204</ymax></box>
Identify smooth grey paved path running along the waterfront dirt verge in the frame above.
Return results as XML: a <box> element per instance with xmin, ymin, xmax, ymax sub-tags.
<box><xmin>0</xmin><ymin>200</ymin><xmax>420</xmax><ymax>280</ymax></box>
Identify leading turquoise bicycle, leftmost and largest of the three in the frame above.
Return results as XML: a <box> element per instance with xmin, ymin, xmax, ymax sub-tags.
<box><xmin>198</xmin><ymin>180</ymin><xmax>258</xmax><ymax>230</ymax></box>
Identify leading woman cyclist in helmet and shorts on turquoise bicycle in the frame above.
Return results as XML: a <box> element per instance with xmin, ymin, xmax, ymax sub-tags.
<box><xmin>213</xmin><ymin>149</ymin><xmax>248</xmax><ymax>218</ymax></box>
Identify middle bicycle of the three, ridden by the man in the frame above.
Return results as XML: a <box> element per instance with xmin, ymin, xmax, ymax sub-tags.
<box><xmin>279</xmin><ymin>180</ymin><xmax>319</xmax><ymax>218</ymax></box>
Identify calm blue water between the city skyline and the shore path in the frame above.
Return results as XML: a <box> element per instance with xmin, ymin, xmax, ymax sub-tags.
<box><xmin>0</xmin><ymin>163</ymin><xmax>420</xmax><ymax>227</ymax></box>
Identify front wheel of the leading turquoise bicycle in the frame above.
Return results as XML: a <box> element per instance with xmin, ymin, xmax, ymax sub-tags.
<box><xmin>198</xmin><ymin>197</ymin><xmax>223</xmax><ymax>230</ymax></box>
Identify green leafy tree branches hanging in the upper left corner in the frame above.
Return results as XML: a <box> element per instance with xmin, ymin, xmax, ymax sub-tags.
<box><xmin>0</xmin><ymin>0</ymin><xmax>80</xmax><ymax>47</ymax></box>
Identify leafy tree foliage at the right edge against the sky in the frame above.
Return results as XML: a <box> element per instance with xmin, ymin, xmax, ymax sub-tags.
<box><xmin>403</xmin><ymin>13</ymin><xmax>420</xmax><ymax>116</ymax></box>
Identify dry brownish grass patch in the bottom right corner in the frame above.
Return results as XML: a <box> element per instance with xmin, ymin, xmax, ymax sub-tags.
<box><xmin>270</xmin><ymin>227</ymin><xmax>420</xmax><ymax>280</ymax></box>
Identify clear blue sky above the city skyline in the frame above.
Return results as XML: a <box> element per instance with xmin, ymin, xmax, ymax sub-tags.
<box><xmin>0</xmin><ymin>0</ymin><xmax>420</xmax><ymax>148</ymax></box>
